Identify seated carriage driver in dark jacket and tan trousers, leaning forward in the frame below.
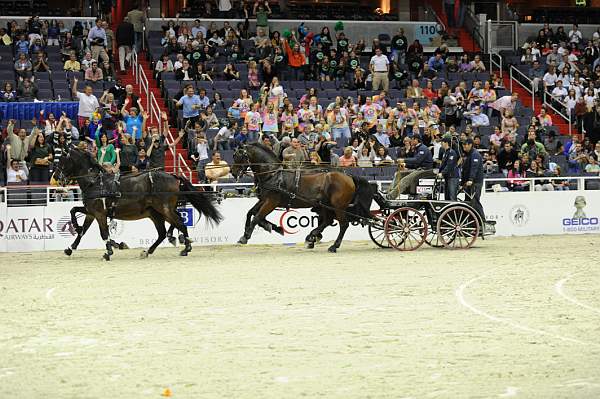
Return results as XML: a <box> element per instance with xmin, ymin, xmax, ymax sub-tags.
<box><xmin>387</xmin><ymin>134</ymin><xmax>435</xmax><ymax>200</ymax></box>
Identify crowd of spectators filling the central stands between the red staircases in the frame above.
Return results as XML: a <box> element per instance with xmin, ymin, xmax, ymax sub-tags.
<box><xmin>155</xmin><ymin>16</ymin><xmax>600</xmax><ymax>190</ymax></box>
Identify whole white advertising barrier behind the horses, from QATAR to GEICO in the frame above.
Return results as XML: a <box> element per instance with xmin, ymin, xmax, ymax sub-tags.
<box><xmin>0</xmin><ymin>191</ymin><xmax>600</xmax><ymax>252</ymax></box>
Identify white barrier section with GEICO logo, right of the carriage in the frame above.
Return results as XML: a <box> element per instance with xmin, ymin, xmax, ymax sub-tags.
<box><xmin>481</xmin><ymin>191</ymin><xmax>600</xmax><ymax>236</ymax></box>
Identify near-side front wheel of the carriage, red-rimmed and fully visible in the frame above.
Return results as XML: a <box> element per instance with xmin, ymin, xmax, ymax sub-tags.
<box><xmin>384</xmin><ymin>207</ymin><xmax>427</xmax><ymax>251</ymax></box>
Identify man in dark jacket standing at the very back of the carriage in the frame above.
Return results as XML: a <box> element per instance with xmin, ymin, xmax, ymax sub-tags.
<box><xmin>461</xmin><ymin>139</ymin><xmax>485</xmax><ymax>222</ymax></box>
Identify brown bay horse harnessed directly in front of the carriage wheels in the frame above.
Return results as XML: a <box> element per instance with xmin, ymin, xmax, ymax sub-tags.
<box><xmin>232</xmin><ymin>143</ymin><xmax>376</xmax><ymax>252</ymax></box>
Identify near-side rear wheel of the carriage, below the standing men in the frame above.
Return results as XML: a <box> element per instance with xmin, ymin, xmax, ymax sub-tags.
<box><xmin>437</xmin><ymin>206</ymin><xmax>479</xmax><ymax>249</ymax></box>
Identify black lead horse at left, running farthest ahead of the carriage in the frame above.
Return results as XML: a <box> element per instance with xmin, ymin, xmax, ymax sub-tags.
<box><xmin>56</xmin><ymin>148</ymin><xmax>222</xmax><ymax>260</ymax></box>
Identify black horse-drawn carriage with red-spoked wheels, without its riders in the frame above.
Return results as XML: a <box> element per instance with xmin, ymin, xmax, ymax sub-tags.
<box><xmin>368</xmin><ymin>179</ymin><xmax>494</xmax><ymax>251</ymax></box>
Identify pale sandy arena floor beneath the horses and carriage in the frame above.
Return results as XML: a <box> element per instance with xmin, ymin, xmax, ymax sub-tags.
<box><xmin>0</xmin><ymin>235</ymin><xmax>600</xmax><ymax>399</ymax></box>
